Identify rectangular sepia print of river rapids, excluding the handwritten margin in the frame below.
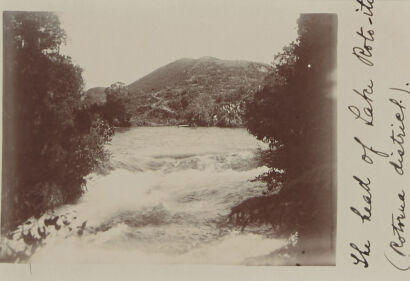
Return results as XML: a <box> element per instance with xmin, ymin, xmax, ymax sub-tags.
<box><xmin>0</xmin><ymin>1</ymin><xmax>338</xmax><ymax>266</ymax></box>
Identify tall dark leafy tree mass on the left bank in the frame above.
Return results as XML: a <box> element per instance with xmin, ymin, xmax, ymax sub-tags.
<box><xmin>1</xmin><ymin>12</ymin><xmax>112</xmax><ymax>231</ymax></box>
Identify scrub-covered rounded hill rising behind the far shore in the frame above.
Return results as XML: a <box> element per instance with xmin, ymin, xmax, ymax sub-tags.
<box><xmin>87</xmin><ymin>57</ymin><xmax>270</xmax><ymax>127</ymax></box>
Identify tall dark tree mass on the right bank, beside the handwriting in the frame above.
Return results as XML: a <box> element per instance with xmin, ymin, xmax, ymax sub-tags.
<box><xmin>235</xmin><ymin>14</ymin><xmax>337</xmax><ymax>245</ymax></box>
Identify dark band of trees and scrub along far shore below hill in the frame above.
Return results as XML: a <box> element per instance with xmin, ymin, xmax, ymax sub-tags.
<box><xmin>85</xmin><ymin>82</ymin><xmax>252</xmax><ymax>127</ymax></box>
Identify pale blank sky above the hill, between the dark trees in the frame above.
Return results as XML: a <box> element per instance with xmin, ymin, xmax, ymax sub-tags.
<box><xmin>59</xmin><ymin>0</ymin><xmax>298</xmax><ymax>89</ymax></box>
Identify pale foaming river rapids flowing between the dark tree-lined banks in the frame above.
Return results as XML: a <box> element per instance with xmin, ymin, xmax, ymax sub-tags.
<box><xmin>20</xmin><ymin>127</ymin><xmax>286</xmax><ymax>264</ymax></box>
